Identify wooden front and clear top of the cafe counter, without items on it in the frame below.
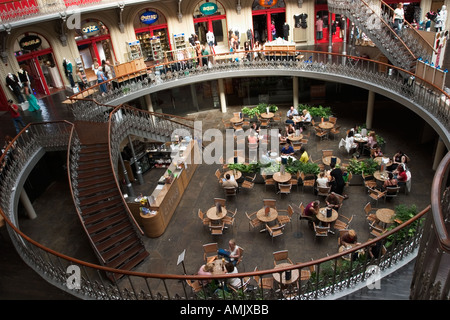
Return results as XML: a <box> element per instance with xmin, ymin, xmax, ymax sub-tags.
<box><xmin>127</xmin><ymin>141</ymin><xmax>198</xmax><ymax>238</ymax></box>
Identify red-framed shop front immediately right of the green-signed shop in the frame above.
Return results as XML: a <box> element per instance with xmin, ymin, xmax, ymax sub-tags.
<box><xmin>252</xmin><ymin>0</ymin><xmax>286</xmax><ymax>43</ymax></box>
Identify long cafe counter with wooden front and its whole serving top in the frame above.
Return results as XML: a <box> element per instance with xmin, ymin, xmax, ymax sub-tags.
<box><xmin>127</xmin><ymin>141</ymin><xmax>198</xmax><ymax>238</ymax></box>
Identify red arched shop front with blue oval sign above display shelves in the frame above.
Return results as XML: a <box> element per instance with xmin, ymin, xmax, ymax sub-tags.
<box><xmin>133</xmin><ymin>8</ymin><xmax>172</xmax><ymax>64</ymax></box>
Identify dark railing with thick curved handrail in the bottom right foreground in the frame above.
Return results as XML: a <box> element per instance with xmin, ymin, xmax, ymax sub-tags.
<box><xmin>410</xmin><ymin>152</ymin><xmax>450</xmax><ymax>300</ymax></box>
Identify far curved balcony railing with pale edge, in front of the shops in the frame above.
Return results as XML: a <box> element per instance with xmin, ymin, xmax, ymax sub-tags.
<box><xmin>70</xmin><ymin>50</ymin><xmax>450</xmax><ymax>144</ymax></box>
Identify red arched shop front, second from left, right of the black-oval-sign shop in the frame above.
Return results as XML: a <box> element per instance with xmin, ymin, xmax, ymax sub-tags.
<box><xmin>75</xmin><ymin>19</ymin><xmax>117</xmax><ymax>80</ymax></box>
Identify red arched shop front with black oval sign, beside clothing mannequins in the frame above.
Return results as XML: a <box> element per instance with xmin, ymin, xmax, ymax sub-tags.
<box><xmin>14</xmin><ymin>32</ymin><xmax>64</xmax><ymax>97</ymax></box>
